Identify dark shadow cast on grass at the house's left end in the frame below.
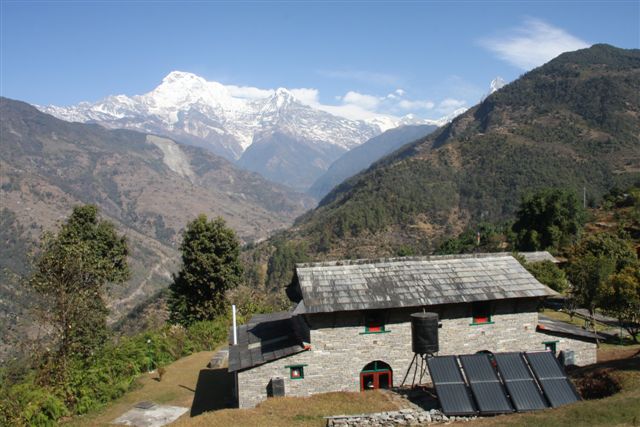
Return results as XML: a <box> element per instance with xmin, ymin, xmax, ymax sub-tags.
<box><xmin>191</xmin><ymin>368</ymin><xmax>233</xmax><ymax>417</ymax></box>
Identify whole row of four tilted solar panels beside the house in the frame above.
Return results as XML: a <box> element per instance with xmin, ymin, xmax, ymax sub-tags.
<box><xmin>427</xmin><ymin>351</ymin><xmax>580</xmax><ymax>415</ymax></box>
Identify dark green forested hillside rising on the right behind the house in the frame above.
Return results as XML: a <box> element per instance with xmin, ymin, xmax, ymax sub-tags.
<box><xmin>248</xmin><ymin>45</ymin><xmax>640</xmax><ymax>286</ymax></box>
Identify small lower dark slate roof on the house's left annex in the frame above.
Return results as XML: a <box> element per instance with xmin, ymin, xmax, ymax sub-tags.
<box><xmin>229</xmin><ymin>312</ymin><xmax>305</xmax><ymax>372</ymax></box>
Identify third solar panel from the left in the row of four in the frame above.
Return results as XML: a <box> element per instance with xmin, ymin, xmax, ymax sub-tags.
<box><xmin>494</xmin><ymin>353</ymin><xmax>548</xmax><ymax>412</ymax></box>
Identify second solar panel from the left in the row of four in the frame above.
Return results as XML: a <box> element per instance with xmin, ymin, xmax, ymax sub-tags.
<box><xmin>460</xmin><ymin>354</ymin><xmax>513</xmax><ymax>414</ymax></box>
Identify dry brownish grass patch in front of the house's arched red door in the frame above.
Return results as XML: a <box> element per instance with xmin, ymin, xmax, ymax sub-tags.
<box><xmin>174</xmin><ymin>391</ymin><xmax>399</xmax><ymax>427</ymax></box>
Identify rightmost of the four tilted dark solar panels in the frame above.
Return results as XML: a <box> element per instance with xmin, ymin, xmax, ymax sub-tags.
<box><xmin>525</xmin><ymin>351</ymin><xmax>580</xmax><ymax>408</ymax></box>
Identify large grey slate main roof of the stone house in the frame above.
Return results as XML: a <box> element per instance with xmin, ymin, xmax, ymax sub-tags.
<box><xmin>293</xmin><ymin>254</ymin><xmax>557</xmax><ymax>313</ymax></box>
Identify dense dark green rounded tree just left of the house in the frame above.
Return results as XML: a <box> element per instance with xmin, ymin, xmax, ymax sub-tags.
<box><xmin>168</xmin><ymin>215</ymin><xmax>242</xmax><ymax>325</ymax></box>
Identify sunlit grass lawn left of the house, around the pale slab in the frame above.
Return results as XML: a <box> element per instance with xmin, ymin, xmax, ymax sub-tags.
<box><xmin>66</xmin><ymin>351</ymin><xmax>215</xmax><ymax>427</ymax></box>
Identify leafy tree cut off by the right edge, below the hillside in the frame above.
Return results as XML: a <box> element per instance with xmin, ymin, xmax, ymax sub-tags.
<box><xmin>601</xmin><ymin>263</ymin><xmax>640</xmax><ymax>343</ymax></box>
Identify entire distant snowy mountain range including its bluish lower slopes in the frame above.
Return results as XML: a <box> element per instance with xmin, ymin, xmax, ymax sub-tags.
<box><xmin>37</xmin><ymin>71</ymin><xmax>464</xmax><ymax>189</ymax></box>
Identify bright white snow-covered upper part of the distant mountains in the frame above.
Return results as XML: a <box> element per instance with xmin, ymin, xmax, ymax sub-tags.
<box><xmin>39</xmin><ymin>70</ymin><xmax>460</xmax><ymax>166</ymax></box>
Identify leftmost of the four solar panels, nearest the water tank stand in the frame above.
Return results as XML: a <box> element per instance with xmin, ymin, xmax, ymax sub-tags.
<box><xmin>427</xmin><ymin>356</ymin><xmax>477</xmax><ymax>415</ymax></box>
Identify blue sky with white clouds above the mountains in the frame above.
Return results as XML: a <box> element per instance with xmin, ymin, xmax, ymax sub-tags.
<box><xmin>0</xmin><ymin>0</ymin><xmax>640</xmax><ymax>118</ymax></box>
